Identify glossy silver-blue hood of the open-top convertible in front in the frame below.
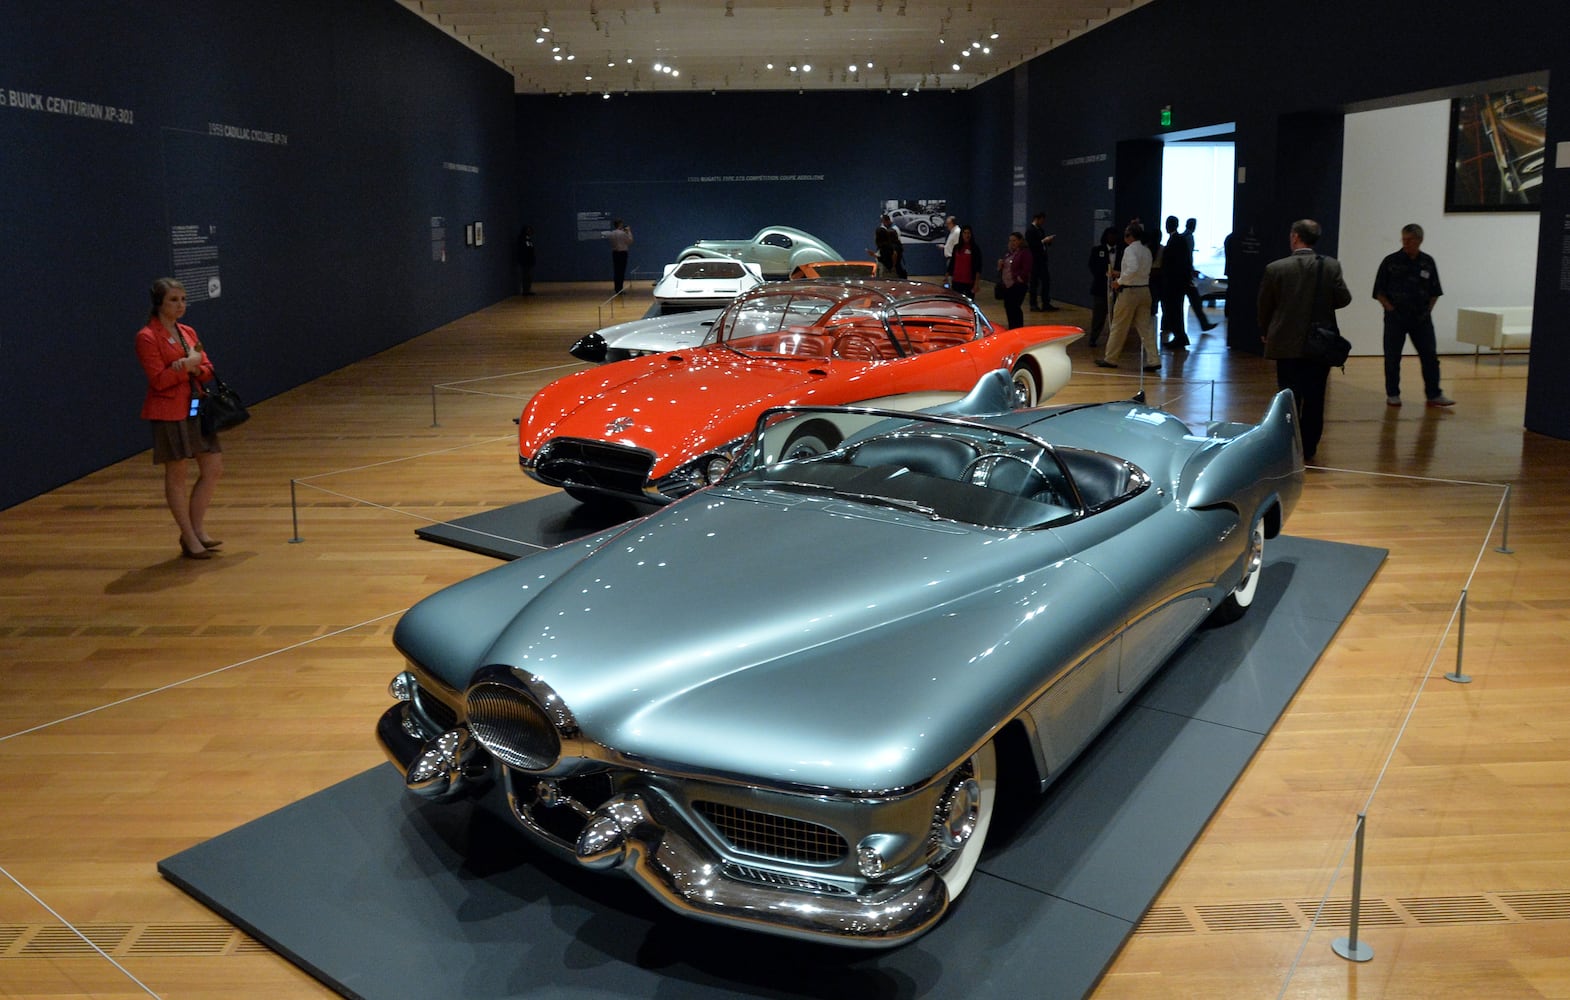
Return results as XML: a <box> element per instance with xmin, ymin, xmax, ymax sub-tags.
<box><xmin>464</xmin><ymin>490</ymin><xmax>1080</xmax><ymax>791</ymax></box>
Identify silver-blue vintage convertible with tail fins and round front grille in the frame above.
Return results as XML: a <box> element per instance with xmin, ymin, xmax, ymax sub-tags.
<box><xmin>377</xmin><ymin>372</ymin><xmax>1303</xmax><ymax>947</ymax></box>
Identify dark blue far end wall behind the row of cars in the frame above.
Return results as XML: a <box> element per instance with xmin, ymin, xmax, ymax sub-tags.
<box><xmin>517</xmin><ymin>93</ymin><xmax>973</xmax><ymax>281</ymax></box>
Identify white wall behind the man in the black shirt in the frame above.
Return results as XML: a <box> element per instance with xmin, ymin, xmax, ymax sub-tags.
<box><xmin>1336</xmin><ymin>100</ymin><xmax>1539</xmax><ymax>355</ymax></box>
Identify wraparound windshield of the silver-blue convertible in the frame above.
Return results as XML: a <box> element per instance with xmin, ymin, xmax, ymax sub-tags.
<box><xmin>721</xmin><ymin>407</ymin><xmax>1085</xmax><ymax>527</ymax></box>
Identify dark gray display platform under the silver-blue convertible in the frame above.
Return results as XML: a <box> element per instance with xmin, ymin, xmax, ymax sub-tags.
<box><xmin>159</xmin><ymin>537</ymin><xmax>1385</xmax><ymax>1000</ymax></box>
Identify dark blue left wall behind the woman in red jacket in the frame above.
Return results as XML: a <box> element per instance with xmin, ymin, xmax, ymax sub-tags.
<box><xmin>0</xmin><ymin>0</ymin><xmax>517</xmax><ymax>507</ymax></box>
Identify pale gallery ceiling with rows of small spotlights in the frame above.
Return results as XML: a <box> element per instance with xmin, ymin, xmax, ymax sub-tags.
<box><xmin>399</xmin><ymin>0</ymin><xmax>1149</xmax><ymax>94</ymax></box>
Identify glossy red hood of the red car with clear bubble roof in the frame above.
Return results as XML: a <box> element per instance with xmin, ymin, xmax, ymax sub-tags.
<box><xmin>518</xmin><ymin>347</ymin><xmax>873</xmax><ymax>479</ymax></box>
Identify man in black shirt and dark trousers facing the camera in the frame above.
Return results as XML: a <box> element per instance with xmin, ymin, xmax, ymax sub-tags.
<box><xmin>1374</xmin><ymin>223</ymin><xmax>1455</xmax><ymax>407</ymax></box>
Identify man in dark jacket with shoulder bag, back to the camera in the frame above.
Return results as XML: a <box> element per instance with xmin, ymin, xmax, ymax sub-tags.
<box><xmin>1259</xmin><ymin>218</ymin><xmax>1352</xmax><ymax>462</ymax></box>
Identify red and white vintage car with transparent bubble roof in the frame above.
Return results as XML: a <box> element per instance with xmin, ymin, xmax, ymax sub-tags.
<box><xmin>518</xmin><ymin>279</ymin><xmax>1083</xmax><ymax>504</ymax></box>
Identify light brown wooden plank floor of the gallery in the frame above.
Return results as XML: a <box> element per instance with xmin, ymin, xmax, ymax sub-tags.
<box><xmin>0</xmin><ymin>286</ymin><xmax>1570</xmax><ymax>1000</ymax></box>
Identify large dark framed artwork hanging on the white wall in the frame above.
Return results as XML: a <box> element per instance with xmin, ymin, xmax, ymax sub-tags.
<box><xmin>1444</xmin><ymin>86</ymin><xmax>1548</xmax><ymax>212</ymax></box>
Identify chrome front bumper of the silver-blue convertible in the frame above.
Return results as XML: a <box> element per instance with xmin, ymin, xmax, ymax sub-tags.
<box><xmin>377</xmin><ymin>702</ymin><xmax>948</xmax><ymax>948</ymax></box>
